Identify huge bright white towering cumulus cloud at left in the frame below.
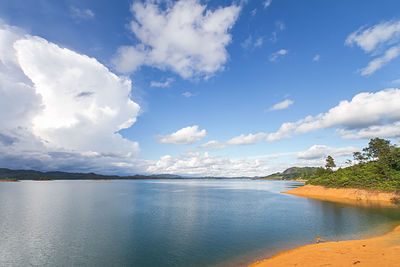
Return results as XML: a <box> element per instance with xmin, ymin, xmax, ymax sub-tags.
<box><xmin>14</xmin><ymin>37</ymin><xmax>139</xmax><ymax>153</ymax></box>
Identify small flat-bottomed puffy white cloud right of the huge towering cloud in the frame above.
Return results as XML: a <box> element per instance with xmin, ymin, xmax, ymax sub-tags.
<box><xmin>156</xmin><ymin>125</ymin><xmax>206</xmax><ymax>145</ymax></box>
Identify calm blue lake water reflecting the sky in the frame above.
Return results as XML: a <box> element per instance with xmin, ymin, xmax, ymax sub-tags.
<box><xmin>0</xmin><ymin>180</ymin><xmax>400</xmax><ymax>266</ymax></box>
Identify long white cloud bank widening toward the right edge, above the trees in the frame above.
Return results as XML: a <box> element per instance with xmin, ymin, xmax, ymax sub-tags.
<box><xmin>267</xmin><ymin>88</ymin><xmax>400</xmax><ymax>141</ymax></box>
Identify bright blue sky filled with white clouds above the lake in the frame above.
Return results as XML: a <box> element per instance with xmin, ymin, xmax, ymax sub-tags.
<box><xmin>0</xmin><ymin>0</ymin><xmax>400</xmax><ymax>177</ymax></box>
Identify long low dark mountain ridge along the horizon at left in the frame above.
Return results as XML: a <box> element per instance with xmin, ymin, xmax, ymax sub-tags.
<box><xmin>0</xmin><ymin>168</ymin><xmax>183</xmax><ymax>180</ymax></box>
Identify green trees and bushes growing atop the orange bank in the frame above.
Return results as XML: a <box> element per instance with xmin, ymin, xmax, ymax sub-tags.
<box><xmin>307</xmin><ymin>138</ymin><xmax>400</xmax><ymax>192</ymax></box>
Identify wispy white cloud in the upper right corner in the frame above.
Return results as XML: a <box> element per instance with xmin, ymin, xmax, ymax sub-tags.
<box><xmin>345</xmin><ymin>21</ymin><xmax>400</xmax><ymax>76</ymax></box>
